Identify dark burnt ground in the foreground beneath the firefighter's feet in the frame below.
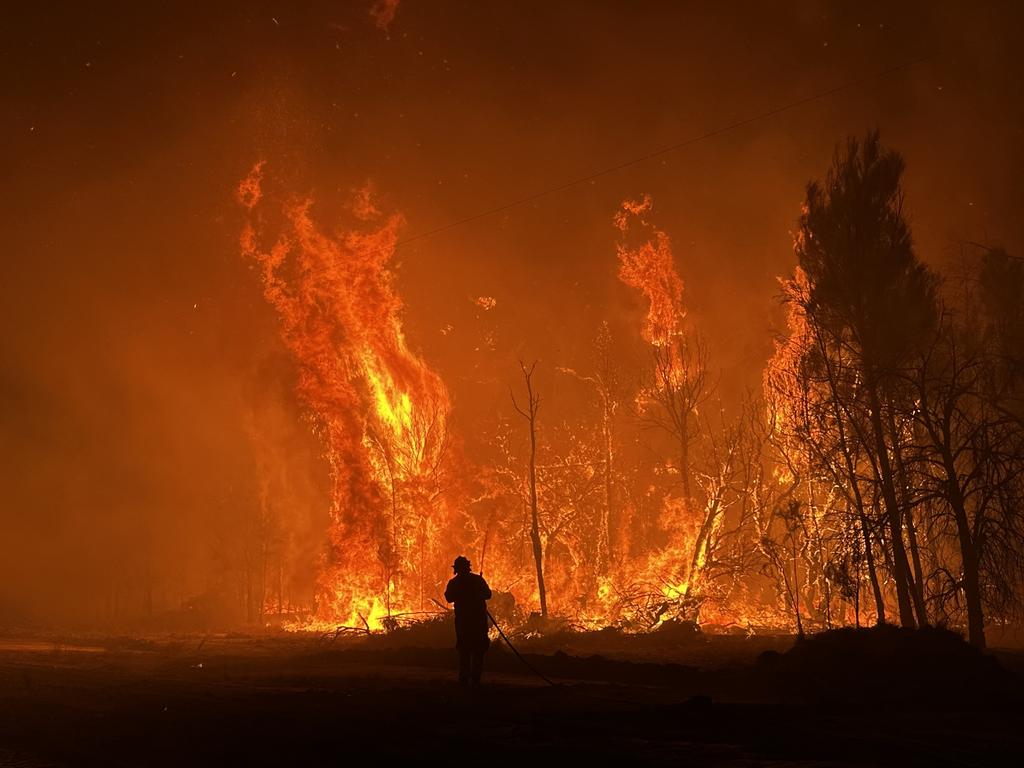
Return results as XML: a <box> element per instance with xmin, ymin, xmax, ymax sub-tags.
<box><xmin>0</xmin><ymin>635</ymin><xmax>1024</xmax><ymax>766</ymax></box>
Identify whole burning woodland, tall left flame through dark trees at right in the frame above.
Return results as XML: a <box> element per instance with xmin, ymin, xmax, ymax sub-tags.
<box><xmin>239</xmin><ymin>134</ymin><xmax>1021</xmax><ymax>647</ymax></box>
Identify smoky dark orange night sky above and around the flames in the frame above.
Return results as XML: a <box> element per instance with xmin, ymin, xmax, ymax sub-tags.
<box><xmin>0</xmin><ymin>0</ymin><xmax>1024</xmax><ymax>622</ymax></box>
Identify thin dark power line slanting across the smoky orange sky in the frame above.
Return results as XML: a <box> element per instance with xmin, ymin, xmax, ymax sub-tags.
<box><xmin>394</xmin><ymin>54</ymin><xmax>934</xmax><ymax>248</ymax></box>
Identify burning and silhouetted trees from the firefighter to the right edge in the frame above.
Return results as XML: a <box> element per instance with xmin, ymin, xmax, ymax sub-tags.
<box><xmin>468</xmin><ymin>132</ymin><xmax>1024</xmax><ymax>647</ymax></box>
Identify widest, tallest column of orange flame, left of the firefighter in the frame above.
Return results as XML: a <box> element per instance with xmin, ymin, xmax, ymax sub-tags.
<box><xmin>238</xmin><ymin>163</ymin><xmax>450</xmax><ymax>629</ymax></box>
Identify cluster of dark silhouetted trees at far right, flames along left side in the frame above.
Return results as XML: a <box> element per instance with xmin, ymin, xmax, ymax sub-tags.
<box><xmin>765</xmin><ymin>133</ymin><xmax>1024</xmax><ymax>646</ymax></box>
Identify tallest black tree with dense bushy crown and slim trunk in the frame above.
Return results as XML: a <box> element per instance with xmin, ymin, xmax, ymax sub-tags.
<box><xmin>796</xmin><ymin>132</ymin><xmax>936</xmax><ymax>627</ymax></box>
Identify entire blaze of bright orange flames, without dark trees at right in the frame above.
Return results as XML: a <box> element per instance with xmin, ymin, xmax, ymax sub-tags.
<box><xmin>238</xmin><ymin>137</ymin><xmax>1024</xmax><ymax>647</ymax></box>
